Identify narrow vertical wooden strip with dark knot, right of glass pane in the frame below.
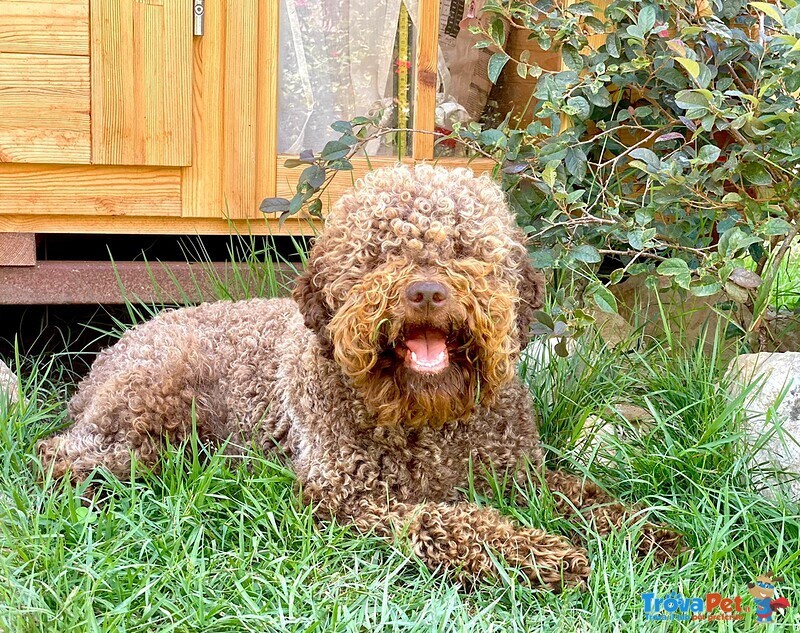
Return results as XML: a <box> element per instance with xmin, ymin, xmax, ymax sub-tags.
<box><xmin>413</xmin><ymin>0</ymin><xmax>439</xmax><ymax>159</ymax></box>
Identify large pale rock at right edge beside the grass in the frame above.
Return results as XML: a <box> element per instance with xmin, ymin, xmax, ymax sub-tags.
<box><xmin>728</xmin><ymin>352</ymin><xmax>800</xmax><ymax>501</ymax></box>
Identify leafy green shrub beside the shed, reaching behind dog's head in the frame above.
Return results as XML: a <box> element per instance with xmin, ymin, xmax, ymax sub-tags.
<box><xmin>266</xmin><ymin>0</ymin><xmax>800</xmax><ymax>340</ymax></box>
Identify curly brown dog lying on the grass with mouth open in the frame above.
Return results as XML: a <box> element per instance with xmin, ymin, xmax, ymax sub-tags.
<box><xmin>39</xmin><ymin>165</ymin><xmax>674</xmax><ymax>590</ymax></box>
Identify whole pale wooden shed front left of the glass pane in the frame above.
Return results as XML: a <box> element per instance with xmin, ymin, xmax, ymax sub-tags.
<box><xmin>0</xmin><ymin>0</ymin><xmax>282</xmax><ymax>234</ymax></box>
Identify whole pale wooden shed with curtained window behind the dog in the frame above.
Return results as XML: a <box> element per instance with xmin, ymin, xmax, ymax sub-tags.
<box><xmin>0</xmin><ymin>0</ymin><xmax>564</xmax><ymax>302</ymax></box>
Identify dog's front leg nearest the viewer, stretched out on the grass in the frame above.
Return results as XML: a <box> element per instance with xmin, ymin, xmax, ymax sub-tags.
<box><xmin>350</xmin><ymin>500</ymin><xmax>590</xmax><ymax>591</ymax></box>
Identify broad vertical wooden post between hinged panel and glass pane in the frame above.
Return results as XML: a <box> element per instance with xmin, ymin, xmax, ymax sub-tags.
<box><xmin>183</xmin><ymin>0</ymin><xmax>278</xmax><ymax>219</ymax></box>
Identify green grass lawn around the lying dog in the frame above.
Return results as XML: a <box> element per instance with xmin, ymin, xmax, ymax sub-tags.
<box><xmin>0</xmin><ymin>244</ymin><xmax>800</xmax><ymax>632</ymax></box>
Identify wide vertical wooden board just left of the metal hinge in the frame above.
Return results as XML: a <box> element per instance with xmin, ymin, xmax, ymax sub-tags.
<box><xmin>90</xmin><ymin>0</ymin><xmax>192</xmax><ymax>166</ymax></box>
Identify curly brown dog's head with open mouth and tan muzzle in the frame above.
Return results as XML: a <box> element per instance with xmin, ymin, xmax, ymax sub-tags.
<box><xmin>294</xmin><ymin>165</ymin><xmax>544</xmax><ymax>425</ymax></box>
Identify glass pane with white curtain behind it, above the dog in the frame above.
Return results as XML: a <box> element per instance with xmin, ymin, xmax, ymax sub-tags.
<box><xmin>278</xmin><ymin>0</ymin><xmax>414</xmax><ymax>156</ymax></box>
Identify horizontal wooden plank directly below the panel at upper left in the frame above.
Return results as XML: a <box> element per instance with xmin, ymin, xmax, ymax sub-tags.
<box><xmin>0</xmin><ymin>164</ymin><xmax>181</xmax><ymax>216</ymax></box>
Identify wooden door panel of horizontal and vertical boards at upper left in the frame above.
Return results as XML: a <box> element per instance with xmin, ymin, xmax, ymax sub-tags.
<box><xmin>0</xmin><ymin>0</ymin><xmax>192</xmax><ymax>166</ymax></box>
